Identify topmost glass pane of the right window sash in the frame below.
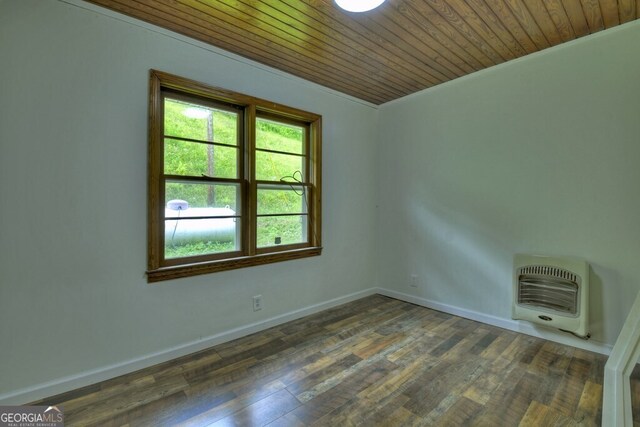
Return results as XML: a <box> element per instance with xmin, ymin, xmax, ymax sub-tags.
<box><xmin>256</xmin><ymin>118</ymin><xmax>305</xmax><ymax>154</ymax></box>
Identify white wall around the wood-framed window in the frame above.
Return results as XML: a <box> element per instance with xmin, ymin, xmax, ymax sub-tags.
<box><xmin>0</xmin><ymin>0</ymin><xmax>377</xmax><ymax>403</ymax></box>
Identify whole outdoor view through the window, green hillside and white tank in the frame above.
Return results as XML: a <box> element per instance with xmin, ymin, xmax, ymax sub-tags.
<box><xmin>164</xmin><ymin>97</ymin><xmax>308</xmax><ymax>258</ymax></box>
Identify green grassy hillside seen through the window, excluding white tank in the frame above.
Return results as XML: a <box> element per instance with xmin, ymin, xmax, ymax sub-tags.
<box><xmin>164</xmin><ymin>99</ymin><xmax>307</xmax><ymax>258</ymax></box>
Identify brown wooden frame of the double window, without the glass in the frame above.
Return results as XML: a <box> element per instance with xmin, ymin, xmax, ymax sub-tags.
<box><xmin>147</xmin><ymin>70</ymin><xmax>322</xmax><ymax>283</ymax></box>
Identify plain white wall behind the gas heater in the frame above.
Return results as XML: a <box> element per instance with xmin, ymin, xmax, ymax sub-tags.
<box><xmin>378</xmin><ymin>21</ymin><xmax>640</xmax><ymax>345</ymax></box>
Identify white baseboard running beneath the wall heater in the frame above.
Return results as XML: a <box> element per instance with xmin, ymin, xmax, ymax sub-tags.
<box><xmin>376</xmin><ymin>288</ymin><xmax>611</xmax><ymax>356</ymax></box>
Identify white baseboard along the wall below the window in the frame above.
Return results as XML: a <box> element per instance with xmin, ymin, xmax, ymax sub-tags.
<box><xmin>0</xmin><ymin>288</ymin><xmax>376</xmax><ymax>405</ymax></box>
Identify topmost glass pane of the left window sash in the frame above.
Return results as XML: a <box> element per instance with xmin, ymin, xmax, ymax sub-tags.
<box><xmin>164</xmin><ymin>98</ymin><xmax>238</xmax><ymax>145</ymax></box>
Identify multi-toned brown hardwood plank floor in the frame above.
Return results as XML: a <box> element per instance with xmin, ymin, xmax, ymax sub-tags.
<box><xmin>28</xmin><ymin>295</ymin><xmax>640</xmax><ymax>427</ymax></box>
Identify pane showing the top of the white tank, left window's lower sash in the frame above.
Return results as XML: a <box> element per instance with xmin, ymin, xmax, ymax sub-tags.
<box><xmin>165</xmin><ymin>182</ymin><xmax>241</xmax><ymax>213</ymax></box>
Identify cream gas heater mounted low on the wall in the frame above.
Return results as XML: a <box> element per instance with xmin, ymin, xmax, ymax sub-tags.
<box><xmin>512</xmin><ymin>254</ymin><xmax>591</xmax><ymax>339</ymax></box>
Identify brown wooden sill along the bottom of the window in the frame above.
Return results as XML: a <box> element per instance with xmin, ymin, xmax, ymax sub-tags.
<box><xmin>147</xmin><ymin>247</ymin><xmax>322</xmax><ymax>283</ymax></box>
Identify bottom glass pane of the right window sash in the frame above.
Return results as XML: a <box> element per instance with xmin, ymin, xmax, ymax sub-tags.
<box><xmin>257</xmin><ymin>215</ymin><xmax>307</xmax><ymax>248</ymax></box>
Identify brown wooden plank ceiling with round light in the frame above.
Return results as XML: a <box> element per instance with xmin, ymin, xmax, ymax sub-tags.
<box><xmin>87</xmin><ymin>0</ymin><xmax>640</xmax><ymax>104</ymax></box>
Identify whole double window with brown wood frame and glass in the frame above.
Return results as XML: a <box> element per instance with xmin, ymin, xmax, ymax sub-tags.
<box><xmin>147</xmin><ymin>70</ymin><xmax>322</xmax><ymax>282</ymax></box>
